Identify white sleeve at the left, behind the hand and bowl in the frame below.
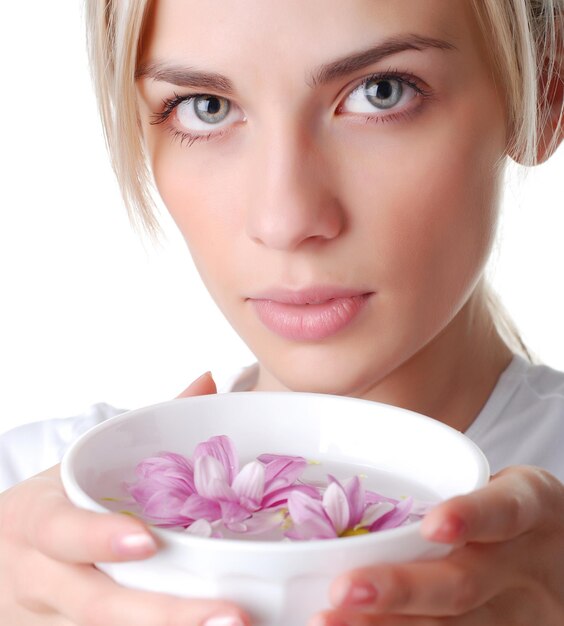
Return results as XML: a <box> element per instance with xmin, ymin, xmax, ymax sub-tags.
<box><xmin>0</xmin><ymin>403</ymin><xmax>123</xmax><ymax>492</ymax></box>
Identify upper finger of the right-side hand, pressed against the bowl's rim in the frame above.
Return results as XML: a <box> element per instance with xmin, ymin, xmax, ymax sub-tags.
<box><xmin>421</xmin><ymin>466</ymin><xmax>562</xmax><ymax>543</ymax></box>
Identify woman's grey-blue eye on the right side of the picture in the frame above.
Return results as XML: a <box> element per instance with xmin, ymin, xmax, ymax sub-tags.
<box><xmin>339</xmin><ymin>76</ymin><xmax>422</xmax><ymax>114</ymax></box>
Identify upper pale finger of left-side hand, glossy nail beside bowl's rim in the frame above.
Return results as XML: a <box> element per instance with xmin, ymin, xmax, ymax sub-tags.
<box><xmin>7</xmin><ymin>467</ymin><xmax>157</xmax><ymax>563</ymax></box>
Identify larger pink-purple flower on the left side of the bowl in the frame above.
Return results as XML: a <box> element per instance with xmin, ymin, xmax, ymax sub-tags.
<box><xmin>129</xmin><ymin>435</ymin><xmax>317</xmax><ymax>536</ymax></box>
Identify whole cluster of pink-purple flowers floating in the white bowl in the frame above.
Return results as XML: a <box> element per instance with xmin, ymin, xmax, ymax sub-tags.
<box><xmin>128</xmin><ymin>435</ymin><xmax>429</xmax><ymax>539</ymax></box>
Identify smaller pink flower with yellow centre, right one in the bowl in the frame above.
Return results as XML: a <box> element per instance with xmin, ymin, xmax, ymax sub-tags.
<box><xmin>286</xmin><ymin>476</ymin><xmax>396</xmax><ymax>539</ymax></box>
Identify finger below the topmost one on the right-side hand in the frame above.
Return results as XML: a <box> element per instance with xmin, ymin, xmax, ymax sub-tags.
<box><xmin>331</xmin><ymin>544</ymin><xmax>508</xmax><ymax>617</ymax></box>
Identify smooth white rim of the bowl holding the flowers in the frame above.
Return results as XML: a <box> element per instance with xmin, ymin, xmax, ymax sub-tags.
<box><xmin>60</xmin><ymin>391</ymin><xmax>490</xmax><ymax>554</ymax></box>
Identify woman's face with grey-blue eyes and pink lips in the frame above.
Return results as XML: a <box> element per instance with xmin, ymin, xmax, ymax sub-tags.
<box><xmin>138</xmin><ymin>0</ymin><xmax>506</xmax><ymax>396</ymax></box>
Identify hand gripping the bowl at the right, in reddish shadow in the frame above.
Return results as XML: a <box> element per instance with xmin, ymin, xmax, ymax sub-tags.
<box><xmin>309</xmin><ymin>466</ymin><xmax>564</xmax><ymax>626</ymax></box>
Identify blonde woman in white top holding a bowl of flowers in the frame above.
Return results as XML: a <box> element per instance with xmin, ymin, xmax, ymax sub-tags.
<box><xmin>0</xmin><ymin>0</ymin><xmax>564</xmax><ymax>626</ymax></box>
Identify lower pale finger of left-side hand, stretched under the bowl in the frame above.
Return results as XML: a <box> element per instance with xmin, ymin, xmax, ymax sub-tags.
<box><xmin>32</xmin><ymin>559</ymin><xmax>250</xmax><ymax>626</ymax></box>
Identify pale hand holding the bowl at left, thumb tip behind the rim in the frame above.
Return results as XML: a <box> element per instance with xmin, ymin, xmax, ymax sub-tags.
<box><xmin>0</xmin><ymin>375</ymin><xmax>249</xmax><ymax>626</ymax></box>
